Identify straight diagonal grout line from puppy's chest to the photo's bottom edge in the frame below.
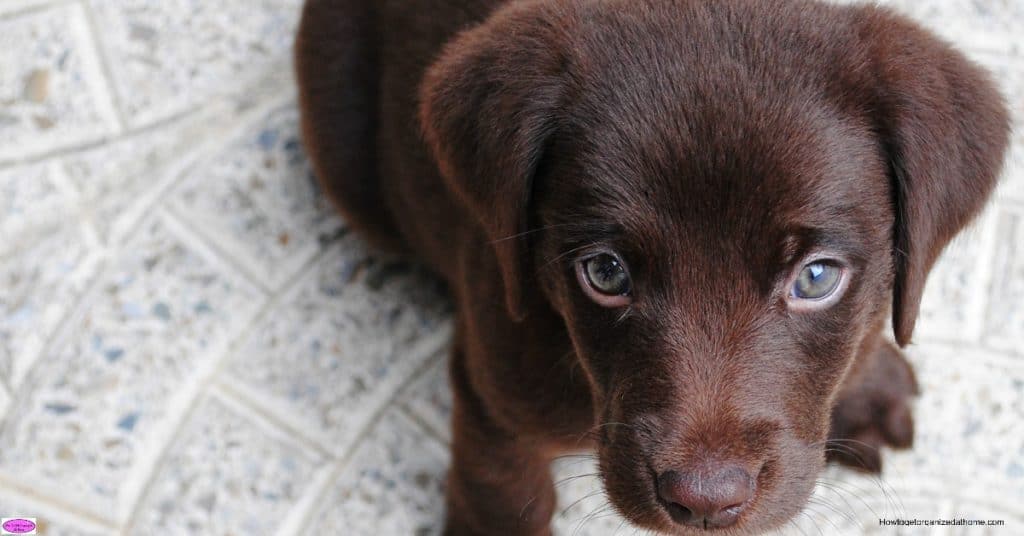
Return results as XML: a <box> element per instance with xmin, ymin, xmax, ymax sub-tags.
<box><xmin>276</xmin><ymin>328</ymin><xmax>453</xmax><ymax>536</ymax></box>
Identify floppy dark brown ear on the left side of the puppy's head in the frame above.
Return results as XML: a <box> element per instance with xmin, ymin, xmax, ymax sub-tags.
<box><xmin>420</xmin><ymin>2</ymin><xmax>568</xmax><ymax>319</ymax></box>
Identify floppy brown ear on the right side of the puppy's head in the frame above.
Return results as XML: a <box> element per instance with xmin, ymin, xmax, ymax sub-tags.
<box><xmin>862</xmin><ymin>8</ymin><xmax>1010</xmax><ymax>346</ymax></box>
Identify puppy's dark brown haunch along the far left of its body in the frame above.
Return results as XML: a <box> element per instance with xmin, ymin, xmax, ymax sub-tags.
<box><xmin>295</xmin><ymin>0</ymin><xmax>403</xmax><ymax>249</ymax></box>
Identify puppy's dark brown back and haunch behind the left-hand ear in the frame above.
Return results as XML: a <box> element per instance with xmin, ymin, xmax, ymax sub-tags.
<box><xmin>295</xmin><ymin>0</ymin><xmax>516</xmax><ymax>272</ymax></box>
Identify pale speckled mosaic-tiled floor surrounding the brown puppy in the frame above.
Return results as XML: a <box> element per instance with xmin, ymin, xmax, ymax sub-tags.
<box><xmin>0</xmin><ymin>0</ymin><xmax>1024</xmax><ymax>535</ymax></box>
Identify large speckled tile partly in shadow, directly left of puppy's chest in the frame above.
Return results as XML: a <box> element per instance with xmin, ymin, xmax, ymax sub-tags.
<box><xmin>225</xmin><ymin>235</ymin><xmax>450</xmax><ymax>449</ymax></box>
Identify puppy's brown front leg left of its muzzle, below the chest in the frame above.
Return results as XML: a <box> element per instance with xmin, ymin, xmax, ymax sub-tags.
<box><xmin>444</xmin><ymin>349</ymin><xmax>555</xmax><ymax>536</ymax></box>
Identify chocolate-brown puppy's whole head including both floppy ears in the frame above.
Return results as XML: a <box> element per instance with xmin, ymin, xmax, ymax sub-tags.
<box><xmin>421</xmin><ymin>0</ymin><xmax>1008</xmax><ymax>533</ymax></box>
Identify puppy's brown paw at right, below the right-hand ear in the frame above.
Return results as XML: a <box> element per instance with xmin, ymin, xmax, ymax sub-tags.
<box><xmin>826</xmin><ymin>342</ymin><xmax>919</xmax><ymax>472</ymax></box>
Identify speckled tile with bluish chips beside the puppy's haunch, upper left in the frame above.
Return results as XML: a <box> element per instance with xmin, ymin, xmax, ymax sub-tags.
<box><xmin>168</xmin><ymin>102</ymin><xmax>341</xmax><ymax>288</ymax></box>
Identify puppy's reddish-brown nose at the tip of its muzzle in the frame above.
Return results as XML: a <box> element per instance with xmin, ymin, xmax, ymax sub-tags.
<box><xmin>657</xmin><ymin>465</ymin><xmax>756</xmax><ymax>529</ymax></box>
